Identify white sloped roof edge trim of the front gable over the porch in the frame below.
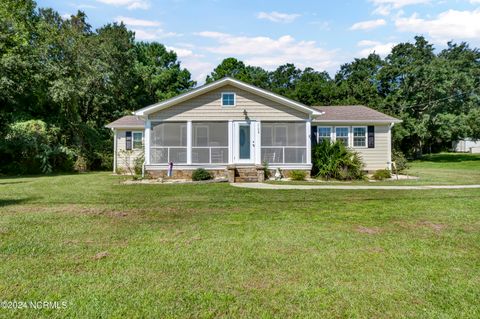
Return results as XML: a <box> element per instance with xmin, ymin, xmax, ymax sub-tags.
<box><xmin>134</xmin><ymin>77</ymin><xmax>321</xmax><ymax>116</ymax></box>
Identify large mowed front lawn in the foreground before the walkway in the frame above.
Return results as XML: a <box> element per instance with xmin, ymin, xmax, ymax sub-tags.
<box><xmin>0</xmin><ymin>165</ymin><xmax>480</xmax><ymax>318</ymax></box>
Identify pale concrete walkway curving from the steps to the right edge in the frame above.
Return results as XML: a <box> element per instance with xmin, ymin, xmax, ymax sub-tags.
<box><xmin>230</xmin><ymin>183</ymin><xmax>480</xmax><ymax>190</ymax></box>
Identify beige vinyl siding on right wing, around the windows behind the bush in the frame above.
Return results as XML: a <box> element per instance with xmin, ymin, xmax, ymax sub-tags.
<box><xmin>312</xmin><ymin>123</ymin><xmax>390</xmax><ymax>171</ymax></box>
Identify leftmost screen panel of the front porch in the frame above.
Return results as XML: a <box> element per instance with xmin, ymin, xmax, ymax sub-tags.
<box><xmin>150</xmin><ymin>122</ymin><xmax>187</xmax><ymax>164</ymax></box>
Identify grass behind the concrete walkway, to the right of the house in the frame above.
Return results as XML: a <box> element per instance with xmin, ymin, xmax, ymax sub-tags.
<box><xmin>268</xmin><ymin>153</ymin><xmax>480</xmax><ymax>185</ymax></box>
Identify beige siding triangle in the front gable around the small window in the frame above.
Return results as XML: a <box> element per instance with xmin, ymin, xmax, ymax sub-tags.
<box><xmin>149</xmin><ymin>85</ymin><xmax>309</xmax><ymax>121</ymax></box>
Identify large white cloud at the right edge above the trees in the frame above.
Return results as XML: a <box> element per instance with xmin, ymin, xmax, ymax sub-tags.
<box><xmin>395</xmin><ymin>9</ymin><xmax>480</xmax><ymax>43</ymax></box>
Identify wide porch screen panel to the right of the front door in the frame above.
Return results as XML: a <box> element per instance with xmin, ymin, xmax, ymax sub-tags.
<box><xmin>261</xmin><ymin>122</ymin><xmax>307</xmax><ymax>164</ymax></box>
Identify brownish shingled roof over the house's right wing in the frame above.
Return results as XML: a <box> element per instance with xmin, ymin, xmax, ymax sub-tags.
<box><xmin>314</xmin><ymin>105</ymin><xmax>402</xmax><ymax>123</ymax></box>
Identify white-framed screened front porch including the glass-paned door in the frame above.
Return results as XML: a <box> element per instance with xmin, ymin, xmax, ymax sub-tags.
<box><xmin>145</xmin><ymin>121</ymin><xmax>310</xmax><ymax>167</ymax></box>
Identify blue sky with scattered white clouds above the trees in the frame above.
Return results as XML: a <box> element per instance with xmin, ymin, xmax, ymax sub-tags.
<box><xmin>37</xmin><ymin>0</ymin><xmax>480</xmax><ymax>83</ymax></box>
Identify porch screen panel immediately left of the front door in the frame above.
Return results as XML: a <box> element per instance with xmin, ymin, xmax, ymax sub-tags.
<box><xmin>192</xmin><ymin>122</ymin><xmax>228</xmax><ymax>164</ymax></box>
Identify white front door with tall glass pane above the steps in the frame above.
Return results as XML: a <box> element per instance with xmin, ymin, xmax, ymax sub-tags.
<box><xmin>233</xmin><ymin>121</ymin><xmax>255</xmax><ymax>164</ymax></box>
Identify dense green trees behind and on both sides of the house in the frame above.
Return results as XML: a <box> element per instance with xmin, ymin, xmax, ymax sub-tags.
<box><xmin>0</xmin><ymin>0</ymin><xmax>480</xmax><ymax>173</ymax></box>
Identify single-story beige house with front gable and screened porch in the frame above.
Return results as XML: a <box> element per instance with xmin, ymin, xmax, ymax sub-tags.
<box><xmin>107</xmin><ymin>78</ymin><xmax>401</xmax><ymax>178</ymax></box>
